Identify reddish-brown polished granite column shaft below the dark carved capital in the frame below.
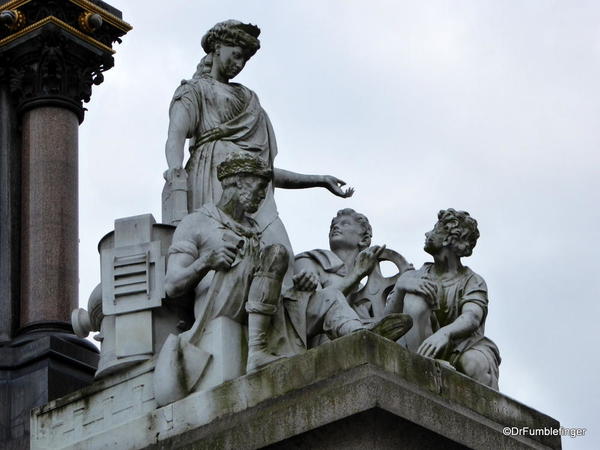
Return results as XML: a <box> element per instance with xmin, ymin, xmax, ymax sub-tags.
<box><xmin>20</xmin><ymin>106</ymin><xmax>79</xmax><ymax>331</ymax></box>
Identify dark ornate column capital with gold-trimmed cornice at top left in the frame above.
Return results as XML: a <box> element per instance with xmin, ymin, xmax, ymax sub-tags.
<box><xmin>0</xmin><ymin>0</ymin><xmax>131</xmax><ymax>121</ymax></box>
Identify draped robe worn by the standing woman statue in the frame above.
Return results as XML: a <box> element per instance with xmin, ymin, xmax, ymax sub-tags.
<box><xmin>171</xmin><ymin>76</ymin><xmax>294</xmax><ymax>258</ymax></box>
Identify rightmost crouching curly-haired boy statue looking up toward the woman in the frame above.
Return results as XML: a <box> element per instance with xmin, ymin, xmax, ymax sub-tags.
<box><xmin>386</xmin><ymin>209</ymin><xmax>500</xmax><ymax>390</ymax></box>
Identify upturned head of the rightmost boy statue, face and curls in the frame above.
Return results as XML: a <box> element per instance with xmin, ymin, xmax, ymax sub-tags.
<box><xmin>425</xmin><ymin>208</ymin><xmax>479</xmax><ymax>257</ymax></box>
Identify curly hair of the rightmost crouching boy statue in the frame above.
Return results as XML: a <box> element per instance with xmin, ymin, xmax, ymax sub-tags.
<box><xmin>438</xmin><ymin>208</ymin><xmax>479</xmax><ymax>257</ymax></box>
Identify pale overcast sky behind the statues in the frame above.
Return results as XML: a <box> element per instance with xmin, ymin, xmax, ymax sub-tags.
<box><xmin>80</xmin><ymin>0</ymin><xmax>600</xmax><ymax>449</ymax></box>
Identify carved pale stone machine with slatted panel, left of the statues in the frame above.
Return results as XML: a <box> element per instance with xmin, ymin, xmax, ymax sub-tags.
<box><xmin>72</xmin><ymin>214</ymin><xmax>193</xmax><ymax>379</ymax></box>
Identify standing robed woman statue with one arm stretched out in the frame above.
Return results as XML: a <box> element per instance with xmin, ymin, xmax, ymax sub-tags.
<box><xmin>165</xmin><ymin>20</ymin><xmax>353</xmax><ymax>255</ymax></box>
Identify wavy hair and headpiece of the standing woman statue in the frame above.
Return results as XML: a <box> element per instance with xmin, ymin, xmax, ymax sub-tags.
<box><xmin>193</xmin><ymin>19</ymin><xmax>260</xmax><ymax>79</ymax></box>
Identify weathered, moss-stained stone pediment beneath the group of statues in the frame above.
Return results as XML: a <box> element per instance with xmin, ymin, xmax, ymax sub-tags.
<box><xmin>31</xmin><ymin>332</ymin><xmax>560</xmax><ymax>450</ymax></box>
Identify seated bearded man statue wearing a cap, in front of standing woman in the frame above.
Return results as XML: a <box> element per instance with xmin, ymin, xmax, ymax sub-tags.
<box><xmin>157</xmin><ymin>152</ymin><xmax>410</xmax><ymax>404</ymax></box>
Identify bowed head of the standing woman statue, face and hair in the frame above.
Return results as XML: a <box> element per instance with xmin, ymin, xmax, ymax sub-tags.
<box><xmin>194</xmin><ymin>20</ymin><xmax>260</xmax><ymax>78</ymax></box>
